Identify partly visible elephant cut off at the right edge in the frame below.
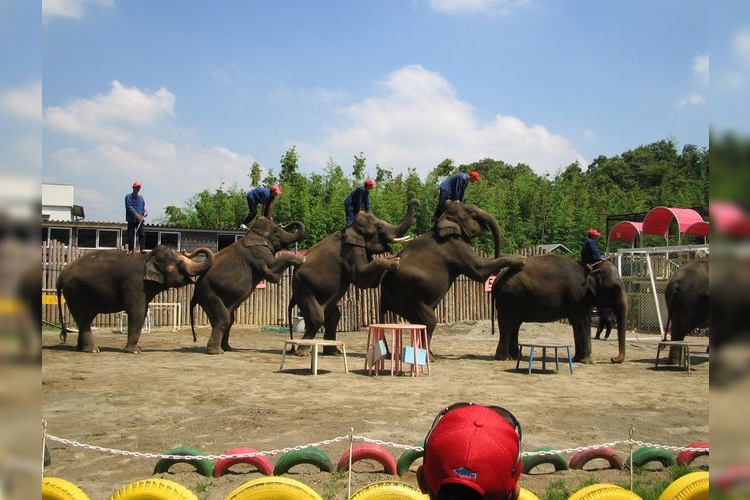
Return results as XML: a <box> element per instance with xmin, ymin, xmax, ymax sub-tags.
<box><xmin>664</xmin><ymin>256</ymin><xmax>709</xmax><ymax>364</ymax></box>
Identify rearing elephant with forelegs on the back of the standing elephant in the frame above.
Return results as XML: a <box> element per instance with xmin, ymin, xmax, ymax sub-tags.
<box><xmin>380</xmin><ymin>201</ymin><xmax>526</xmax><ymax>352</ymax></box>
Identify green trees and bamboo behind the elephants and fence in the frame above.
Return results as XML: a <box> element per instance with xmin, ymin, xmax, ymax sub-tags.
<box><xmin>159</xmin><ymin>139</ymin><xmax>709</xmax><ymax>253</ymax></box>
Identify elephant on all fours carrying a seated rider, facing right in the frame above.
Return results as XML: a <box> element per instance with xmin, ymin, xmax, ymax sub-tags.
<box><xmin>491</xmin><ymin>254</ymin><xmax>628</xmax><ymax>363</ymax></box>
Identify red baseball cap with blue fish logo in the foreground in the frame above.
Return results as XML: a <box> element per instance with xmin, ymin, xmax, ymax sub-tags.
<box><xmin>422</xmin><ymin>404</ymin><xmax>523</xmax><ymax>499</ymax></box>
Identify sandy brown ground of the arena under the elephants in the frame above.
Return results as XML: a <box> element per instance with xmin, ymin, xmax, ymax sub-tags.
<box><xmin>42</xmin><ymin>321</ymin><xmax>709</xmax><ymax>499</ymax></box>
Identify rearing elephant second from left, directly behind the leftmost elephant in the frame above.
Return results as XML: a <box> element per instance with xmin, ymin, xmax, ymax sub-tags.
<box><xmin>190</xmin><ymin>217</ymin><xmax>306</xmax><ymax>354</ymax></box>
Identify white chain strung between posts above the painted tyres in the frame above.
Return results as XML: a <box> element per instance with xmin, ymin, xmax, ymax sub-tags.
<box><xmin>47</xmin><ymin>434</ymin><xmax>708</xmax><ymax>460</ymax></box>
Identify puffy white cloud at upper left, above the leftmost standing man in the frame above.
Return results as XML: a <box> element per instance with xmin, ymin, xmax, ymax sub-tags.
<box><xmin>44</xmin><ymin>80</ymin><xmax>175</xmax><ymax>143</ymax></box>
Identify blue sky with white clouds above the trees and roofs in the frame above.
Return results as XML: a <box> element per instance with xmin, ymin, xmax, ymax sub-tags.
<box><xmin>0</xmin><ymin>0</ymin><xmax>750</xmax><ymax>221</ymax></box>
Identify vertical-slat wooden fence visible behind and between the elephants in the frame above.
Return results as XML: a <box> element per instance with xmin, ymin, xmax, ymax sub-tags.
<box><xmin>42</xmin><ymin>241</ymin><xmax>540</xmax><ymax>331</ymax></box>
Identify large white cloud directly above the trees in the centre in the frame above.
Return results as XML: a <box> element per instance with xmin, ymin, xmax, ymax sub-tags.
<box><xmin>296</xmin><ymin>65</ymin><xmax>586</xmax><ymax>175</ymax></box>
